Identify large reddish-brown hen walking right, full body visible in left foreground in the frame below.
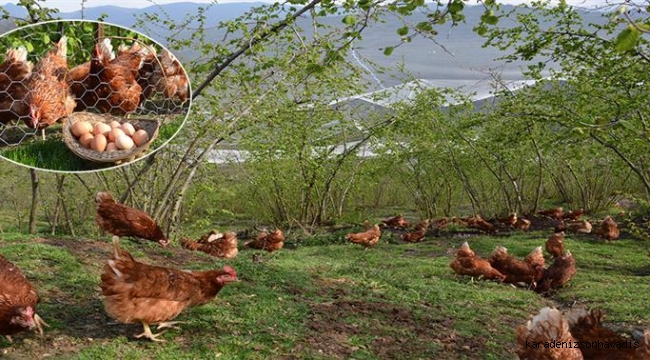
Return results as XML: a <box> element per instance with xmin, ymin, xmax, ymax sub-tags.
<box><xmin>100</xmin><ymin>238</ymin><xmax>237</xmax><ymax>341</ymax></box>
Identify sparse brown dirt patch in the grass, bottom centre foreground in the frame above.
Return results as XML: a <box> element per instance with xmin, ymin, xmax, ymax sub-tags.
<box><xmin>301</xmin><ymin>301</ymin><xmax>480</xmax><ymax>358</ymax></box>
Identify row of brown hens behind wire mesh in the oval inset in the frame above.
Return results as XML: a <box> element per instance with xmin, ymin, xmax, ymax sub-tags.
<box><xmin>0</xmin><ymin>35</ymin><xmax>189</xmax><ymax>136</ymax></box>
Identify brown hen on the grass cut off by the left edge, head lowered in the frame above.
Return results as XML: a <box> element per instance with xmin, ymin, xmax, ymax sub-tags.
<box><xmin>0</xmin><ymin>255</ymin><xmax>47</xmax><ymax>340</ymax></box>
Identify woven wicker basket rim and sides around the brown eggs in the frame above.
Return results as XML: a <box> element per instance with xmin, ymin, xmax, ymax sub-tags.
<box><xmin>62</xmin><ymin>112</ymin><xmax>160</xmax><ymax>164</ymax></box>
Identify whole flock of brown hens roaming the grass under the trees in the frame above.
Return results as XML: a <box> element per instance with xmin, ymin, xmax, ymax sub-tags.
<box><xmin>0</xmin><ymin>197</ymin><xmax>650</xmax><ymax>359</ymax></box>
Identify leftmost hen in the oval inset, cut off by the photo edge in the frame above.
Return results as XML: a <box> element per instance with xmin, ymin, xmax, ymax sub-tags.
<box><xmin>0</xmin><ymin>46</ymin><xmax>34</xmax><ymax>124</ymax></box>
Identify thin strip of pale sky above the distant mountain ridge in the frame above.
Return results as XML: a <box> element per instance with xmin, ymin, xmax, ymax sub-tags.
<box><xmin>0</xmin><ymin>0</ymin><xmax>606</xmax><ymax>12</ymax></box>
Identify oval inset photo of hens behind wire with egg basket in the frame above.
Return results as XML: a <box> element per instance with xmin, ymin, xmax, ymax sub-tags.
<box><xmin>0</xmin><ymin>20</ymin><xmax>191</xmax><ymax>172</ymax></box>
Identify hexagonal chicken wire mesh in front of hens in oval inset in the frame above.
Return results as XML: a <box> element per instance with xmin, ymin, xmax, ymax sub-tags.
<box><xmin>0</xmin><ymin>21</ymin><xmax>191</xmax><ymax>158</ymax></box>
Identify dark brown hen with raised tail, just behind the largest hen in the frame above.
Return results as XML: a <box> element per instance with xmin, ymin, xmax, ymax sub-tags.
<box><xmin>95</xmin><ymin>192</ymin><xmax>169</xmax><ymax>247</ymax></box>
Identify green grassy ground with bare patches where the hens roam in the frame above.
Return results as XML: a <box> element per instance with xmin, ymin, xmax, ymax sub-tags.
<box><xmin>0</xmin><ymin>234</ymin><xmax>650</xmax><ymax>359</ymax></box>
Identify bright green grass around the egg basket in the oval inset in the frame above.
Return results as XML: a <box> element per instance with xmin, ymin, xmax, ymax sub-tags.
<box><xmin>0</xmin><ymin>115</ymin><xmax>185</xmax><ymax>171</ymax></box>
